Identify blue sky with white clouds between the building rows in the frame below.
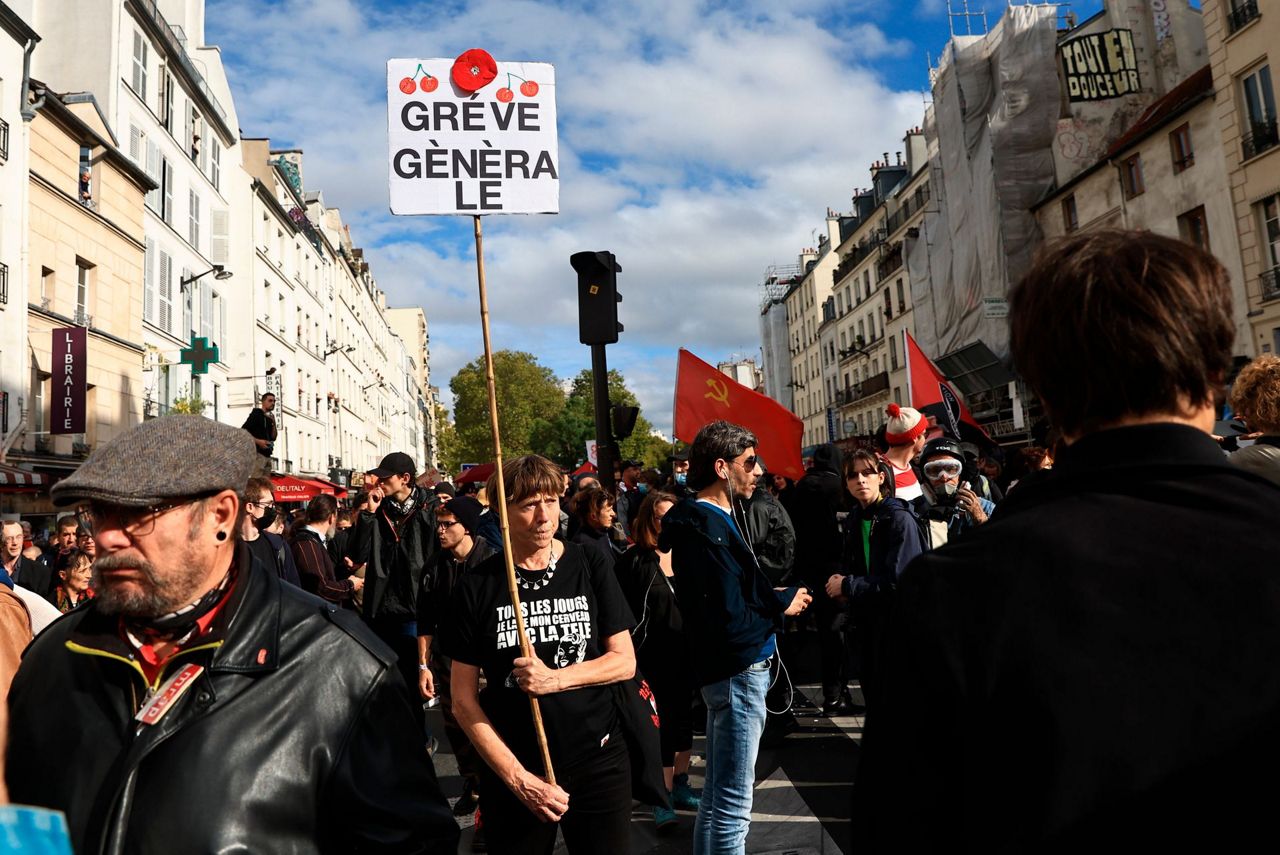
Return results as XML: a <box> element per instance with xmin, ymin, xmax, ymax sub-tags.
<box><xmin>205</xmin><ymin>0</ymin><xmax>1100</xmax><ymax>430</ymax></box>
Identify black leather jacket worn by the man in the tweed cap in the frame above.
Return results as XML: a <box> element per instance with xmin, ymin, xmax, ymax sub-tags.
<box><xmin>5</xmin><ymin>544</ymin><xmax>458</xmax><ymax>855</ymax></box>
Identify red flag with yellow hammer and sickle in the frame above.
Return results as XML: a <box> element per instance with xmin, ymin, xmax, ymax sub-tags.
<box><xmin>675</xmin><ymin>348</ymin><xmax>804</xmax><ymax>480</ymax></box>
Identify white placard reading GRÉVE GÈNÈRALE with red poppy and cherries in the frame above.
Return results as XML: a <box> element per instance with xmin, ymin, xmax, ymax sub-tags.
<box><xmin>387</xmin><ymin>50</ymin><xmax>559</xmax><ymax>215</ymax></box>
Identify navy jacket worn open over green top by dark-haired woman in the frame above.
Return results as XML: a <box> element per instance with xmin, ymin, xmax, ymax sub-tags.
<box><xmin>841</xmin><ymin>499</ymin><xmax>928</xmax><ymax>598</ymax></box>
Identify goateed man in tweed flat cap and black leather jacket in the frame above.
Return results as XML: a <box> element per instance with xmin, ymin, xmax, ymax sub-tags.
<box><xmin>5</xmin><ymin>416</ymin><xmax>458</xmax><ymax>855</ymax></box>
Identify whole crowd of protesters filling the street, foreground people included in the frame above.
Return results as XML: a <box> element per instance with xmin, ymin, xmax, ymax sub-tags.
<box><xmin>0</xmin><ymin>232</ymin><xmax>1280</xmax><ymax>855</ymax></box>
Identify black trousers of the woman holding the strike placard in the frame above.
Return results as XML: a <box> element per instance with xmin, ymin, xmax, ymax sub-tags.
<box><xmin>480</xmin><ymin>732</ymin><xmax>631</xmax><ymax>855</ymax></box>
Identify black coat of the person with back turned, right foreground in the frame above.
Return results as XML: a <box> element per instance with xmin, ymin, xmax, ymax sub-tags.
<box><xmin>854</xmin><ymin>425</ymin><xmax>1280</xmax><ymax>852</ymax></box>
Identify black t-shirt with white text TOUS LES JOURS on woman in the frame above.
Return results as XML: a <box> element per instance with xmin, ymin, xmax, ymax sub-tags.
<box><xmin>439</xmin><ymin>544</ymin><xmax>635</xmax><ymax>772</ymax></box>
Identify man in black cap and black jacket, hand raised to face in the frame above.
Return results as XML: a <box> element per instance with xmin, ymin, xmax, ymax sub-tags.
<box><xmin>347</xmin><ymin>452</ymin><xmax>440</xmax><ymax>732</ymax></box>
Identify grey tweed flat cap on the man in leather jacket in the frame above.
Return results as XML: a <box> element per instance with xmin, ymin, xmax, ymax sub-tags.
<box><xmin>51</xmin><ymin>416</ymin><xmax>257</xmax><ymax>507</ymax></box>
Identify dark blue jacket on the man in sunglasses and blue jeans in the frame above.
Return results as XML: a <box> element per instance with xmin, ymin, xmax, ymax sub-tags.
<box><xmin>658</xmin><ymin>499</ymin><xmax>796</xmax><ymax>686</ymax></box>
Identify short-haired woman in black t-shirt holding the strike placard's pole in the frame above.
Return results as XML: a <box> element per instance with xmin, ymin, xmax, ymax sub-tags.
<box><xmin>440</xmin><ymin>454</ymin><xmax>635</xmax><ymax>854</ymax></box>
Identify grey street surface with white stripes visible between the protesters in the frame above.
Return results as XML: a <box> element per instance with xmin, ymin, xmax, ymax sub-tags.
<box><xmin>429</xmin><ymin>632</ymin><xmax>863</xmax><ymax>855</ymax></box>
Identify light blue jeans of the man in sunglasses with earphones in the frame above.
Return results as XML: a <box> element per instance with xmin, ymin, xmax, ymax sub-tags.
<box><xmin>694</xmin><ymin>659</ymin><xmax>771</xmax><ymax>855</ymax></box>
